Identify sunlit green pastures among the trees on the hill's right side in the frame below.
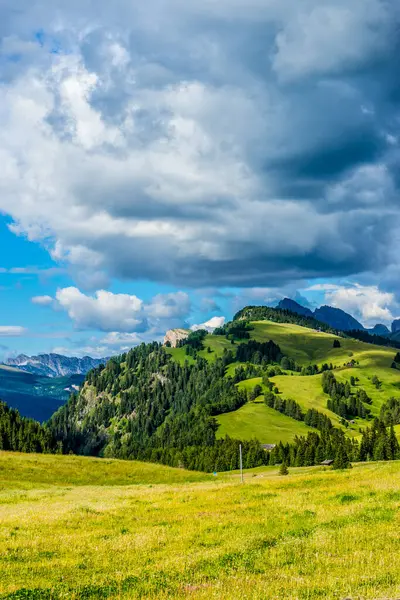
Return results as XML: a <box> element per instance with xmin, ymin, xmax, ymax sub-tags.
<box><xmin>212</xmin><ymin>321</ymin><xmax>400</xmax><ymax>443</ymax></box>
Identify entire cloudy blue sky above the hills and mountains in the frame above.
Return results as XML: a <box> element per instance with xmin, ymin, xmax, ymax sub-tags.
<box><xmin>0</xmin><ymin>0</ymin><xmax>400</xmax><ymax>359</ymax></box>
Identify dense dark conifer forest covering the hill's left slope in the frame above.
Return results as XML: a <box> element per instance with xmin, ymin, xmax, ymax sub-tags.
<box><xmin>49</xmin><ymin>338</ymin><xmax>282</xmax><ymax>470</ymax></box>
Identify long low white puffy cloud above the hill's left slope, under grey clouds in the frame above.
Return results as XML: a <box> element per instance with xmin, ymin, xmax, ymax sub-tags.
<box><xmin>56</xmin><ymin>287</ymin><xmax>190</xmax><ymax>332</ymax></box>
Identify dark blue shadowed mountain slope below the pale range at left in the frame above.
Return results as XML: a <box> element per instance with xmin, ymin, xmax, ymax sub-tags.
<box><xmin>0</xmin><ymin>366</ymin><xmax>85</xmax><ymax>421</ymax></box>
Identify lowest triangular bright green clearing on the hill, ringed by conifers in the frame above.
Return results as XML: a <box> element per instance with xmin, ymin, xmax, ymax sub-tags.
<box><xmin>217</xmin><ymin>399</ymin><xmax>314</xmax><ymax>444</ymax></box>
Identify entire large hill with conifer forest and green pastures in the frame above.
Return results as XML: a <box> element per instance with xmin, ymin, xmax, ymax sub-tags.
<box><xmin>4</xmin><ymin>307</ymin><xmax>400</xmax><ymax>471</ymax></box>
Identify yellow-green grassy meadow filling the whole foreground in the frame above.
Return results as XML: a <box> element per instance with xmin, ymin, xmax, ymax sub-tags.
<box><xmin>0</xmin><ymin>452</ymin><xmax>400</xmax><ymax>600</ymax></box>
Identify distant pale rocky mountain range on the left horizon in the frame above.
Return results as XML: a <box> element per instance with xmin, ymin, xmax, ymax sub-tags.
<box><xmin>5</xmin><ymin>354</ymin><xmax>108</xmax><ymax>377</ymax></box>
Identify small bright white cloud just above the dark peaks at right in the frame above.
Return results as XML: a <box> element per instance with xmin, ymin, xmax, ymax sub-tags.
<box><xmin>325</xmin><ymin>284</ymin><xmax>399</xmax><ymax>326</ymax></box>
